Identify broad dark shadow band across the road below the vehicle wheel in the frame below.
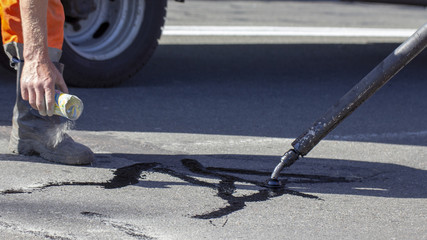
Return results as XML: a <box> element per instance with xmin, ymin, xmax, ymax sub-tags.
<box><xmin>0</xmin><ymin>43</ymin><xmax>427</xmax><ymax>146</ymax></box>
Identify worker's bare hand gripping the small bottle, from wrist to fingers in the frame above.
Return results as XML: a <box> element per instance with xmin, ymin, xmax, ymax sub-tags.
<box><xmin>21</xmin><ymin>60</ymin><xmax>68</xmax><ymax>116</ymax></box>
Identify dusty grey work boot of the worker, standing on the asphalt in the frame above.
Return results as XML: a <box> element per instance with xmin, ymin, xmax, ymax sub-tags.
<box><xmin>5</xmin><ymin>43</ymin><xmax>94</xmax><ymax>165</ymax></box>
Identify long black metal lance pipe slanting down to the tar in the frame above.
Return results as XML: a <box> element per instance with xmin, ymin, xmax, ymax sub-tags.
<box><xmin>268</xmin><ymin>24</ymin><xmax>427</xmax><ymax>187</ymax></box>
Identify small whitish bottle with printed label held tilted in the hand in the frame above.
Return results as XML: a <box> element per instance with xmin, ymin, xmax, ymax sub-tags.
<box><xmin>54</xmin><ymin>91</ymin><xmax>83</xmax><ymax>121</ymax></box>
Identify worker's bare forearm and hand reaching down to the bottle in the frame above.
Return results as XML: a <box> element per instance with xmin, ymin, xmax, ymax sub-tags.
<box><xmin>20</xmin><ymin>0</ymin><xmax>68</xmax><ymax>116</ymax></box>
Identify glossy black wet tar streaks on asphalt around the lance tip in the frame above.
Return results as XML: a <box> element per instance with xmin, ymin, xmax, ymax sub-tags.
<box><xmin>104</xmin><ymin>159</ymin><xmax>350</xmax><ymax>219</ymax></box>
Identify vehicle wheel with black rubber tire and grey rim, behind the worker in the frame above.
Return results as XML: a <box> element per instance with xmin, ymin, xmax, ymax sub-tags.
<box><xmin>61</xmin><ymin>0</ymin><xmax>167</xmax><ymax>87</ymax></box>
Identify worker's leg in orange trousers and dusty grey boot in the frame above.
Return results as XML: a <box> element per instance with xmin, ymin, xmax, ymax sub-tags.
<box><xmin>1</xmin><ymin>0</ymin><xmax>93</xmax><ymax>164</ymax></box>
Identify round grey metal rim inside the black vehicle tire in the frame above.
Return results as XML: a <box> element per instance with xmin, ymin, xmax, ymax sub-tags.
<box><xmin>64</xmin><ymin>0</ymin><xmax>145</xmax><ymax>61</ymax></box>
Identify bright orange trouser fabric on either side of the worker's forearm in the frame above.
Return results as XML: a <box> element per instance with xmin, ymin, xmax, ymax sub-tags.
<box><xmin>0</xmin><ymin>0</ymin><xmax>65</xmax><ymax>49</ymax></box>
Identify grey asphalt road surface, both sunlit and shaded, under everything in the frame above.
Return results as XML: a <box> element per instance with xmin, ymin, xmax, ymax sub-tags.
<box><xmin>0</xmin><ymin>0</ymin><xmax>427</xmax><ymax>239</ymax></box>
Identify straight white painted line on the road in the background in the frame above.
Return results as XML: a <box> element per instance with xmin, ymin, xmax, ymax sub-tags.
<box><xmin>163</xmin><ymin>26</ymin><xmax>416</xmax><ymax>38</ymax></box>
